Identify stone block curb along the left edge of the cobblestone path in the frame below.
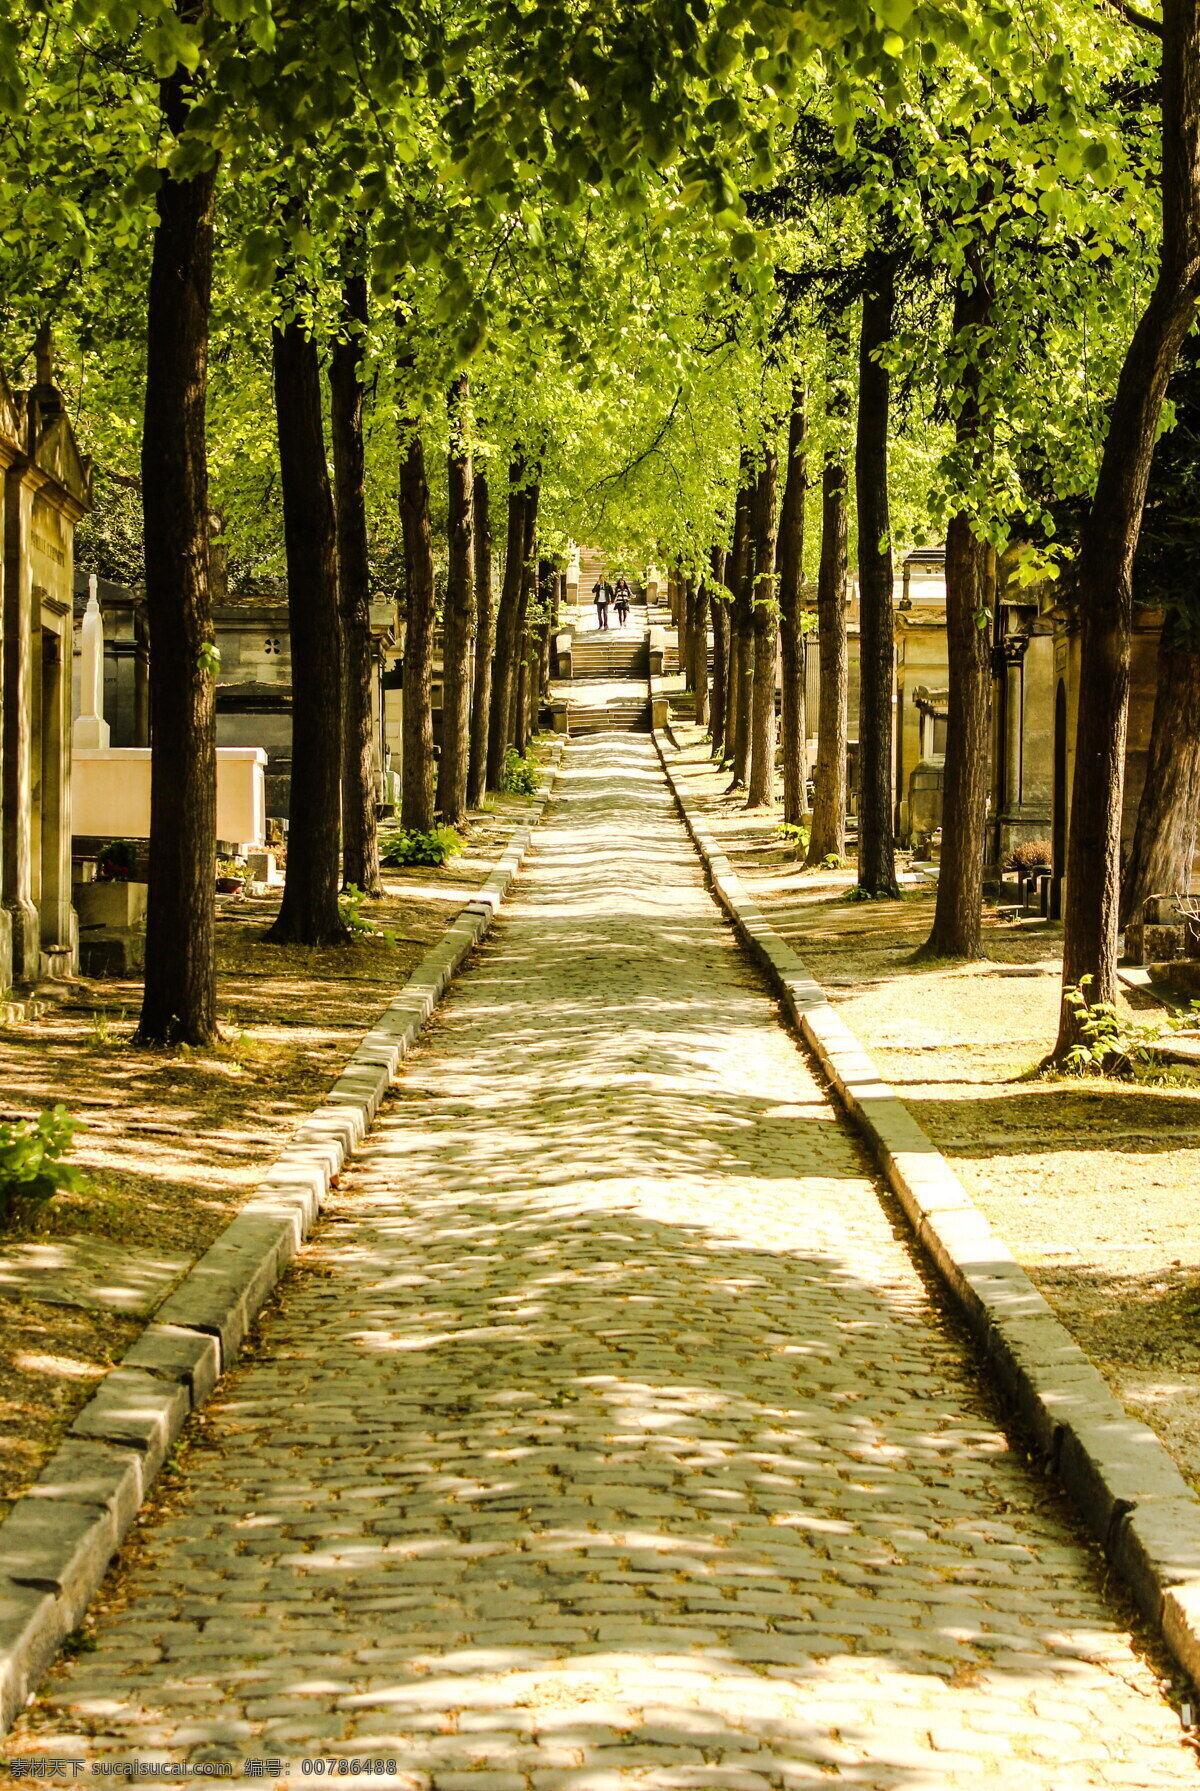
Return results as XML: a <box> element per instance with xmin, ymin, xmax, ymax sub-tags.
<box><xmin>0</xmin><ymin>743</ymin><xmax>562</xmax><ymax>1734</ymax></box>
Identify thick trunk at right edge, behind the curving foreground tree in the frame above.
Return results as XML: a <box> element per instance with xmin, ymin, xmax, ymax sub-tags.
<box><xmin>1121</xmin><ymin>611</ymin><xmax>1200</xmax><ymax>926</ymax></box>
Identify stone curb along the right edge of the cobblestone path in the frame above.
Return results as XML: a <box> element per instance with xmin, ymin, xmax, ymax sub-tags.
<box><xmin>654</xmin><ymin>733</ymin><xmax>1200</xmax><ymax>1684</ymax></box>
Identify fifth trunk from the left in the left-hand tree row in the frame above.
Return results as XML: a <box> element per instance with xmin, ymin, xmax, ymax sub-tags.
<box><xmin>437</xmin><ymin>376</ymin><xmax>475</xmax><ymax>827</ymax></box>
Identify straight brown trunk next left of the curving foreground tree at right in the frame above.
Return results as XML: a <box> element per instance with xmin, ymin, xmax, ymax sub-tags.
<box><xmin>922</xmin><ymin>257</ymin><xmax>996</xmax><ymax>958</ymax></box>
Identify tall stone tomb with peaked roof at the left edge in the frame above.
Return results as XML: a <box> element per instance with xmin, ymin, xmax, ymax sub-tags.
<box><xmin>0</xmin><ymin>331</ymin><xmax>91</xmax><ymax>985</ymax></box>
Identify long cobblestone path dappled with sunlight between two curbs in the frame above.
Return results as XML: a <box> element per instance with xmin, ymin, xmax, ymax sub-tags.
<box><xmin>4</xmin><ymin>736</ymin><xmax>1196</xmax><ymax>1791</ymax></box>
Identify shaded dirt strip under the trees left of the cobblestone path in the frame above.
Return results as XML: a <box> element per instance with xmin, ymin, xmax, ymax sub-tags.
<box><xmin>0</xmin><ymin>777</ymin><xmax>551</xmax><ymax>1517</ymax></box>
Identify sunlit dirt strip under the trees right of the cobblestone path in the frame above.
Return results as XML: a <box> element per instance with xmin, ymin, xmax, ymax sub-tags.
<box><xmin>673</xmin><ymin>722</ymin><xmax>1200</xmax><ymax>1488</ymax></box>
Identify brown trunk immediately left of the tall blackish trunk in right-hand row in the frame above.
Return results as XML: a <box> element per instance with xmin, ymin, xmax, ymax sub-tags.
<box><xmin>806</xmin><ymin>453</ymin><xmax>849</xmax><ymax>865</ymax></box>
